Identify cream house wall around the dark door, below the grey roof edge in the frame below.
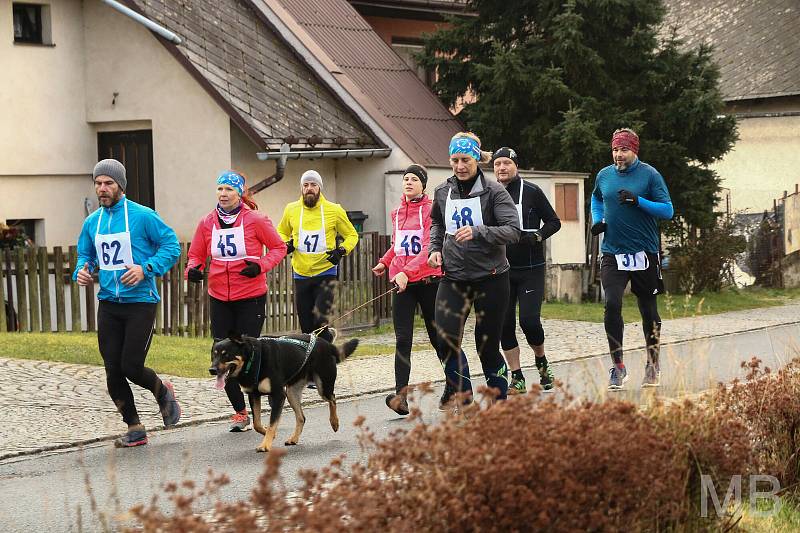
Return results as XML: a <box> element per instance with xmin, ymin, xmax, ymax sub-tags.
<box><xmin>83</xmin><ymin>2</ymin><xmax>231</xmax><ymax>240</ymax></box>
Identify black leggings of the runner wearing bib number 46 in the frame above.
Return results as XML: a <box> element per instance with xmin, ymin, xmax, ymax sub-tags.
<box><xmin>392</xmin><ymin>281</ymin><xmax>469</xmax><ymax>393</ymax></box>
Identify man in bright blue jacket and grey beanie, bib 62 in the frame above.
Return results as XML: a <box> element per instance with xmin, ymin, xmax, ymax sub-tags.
<box><xmin>72</xmin><ymin>159</ymin><xmax>181</xmax><ymax>448</ymax></box>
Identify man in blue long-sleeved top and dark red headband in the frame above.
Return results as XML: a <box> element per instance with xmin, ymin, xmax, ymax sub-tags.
<box><xmin>592</xmin><ymin>128</ymin><xmax>673</xmax><ymax>390</ymax></box>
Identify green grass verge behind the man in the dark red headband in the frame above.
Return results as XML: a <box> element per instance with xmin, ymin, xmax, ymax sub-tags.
<box><xmin>542</xmin><ymin>287</ymin><xmax>800</xmax><ymax>322</ymax></box>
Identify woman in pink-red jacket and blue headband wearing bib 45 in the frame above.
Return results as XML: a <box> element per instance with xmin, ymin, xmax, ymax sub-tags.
<box><xmin>186</xmin><ymin>170</ymin><xmax>286</xmax><ymax>431</ymax></box>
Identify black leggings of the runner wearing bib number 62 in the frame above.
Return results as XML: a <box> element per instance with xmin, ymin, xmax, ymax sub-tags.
<box><xmin>97</xmin><ymin>300</ymin><xmax>166</xmax><ymax>426</ymax></box>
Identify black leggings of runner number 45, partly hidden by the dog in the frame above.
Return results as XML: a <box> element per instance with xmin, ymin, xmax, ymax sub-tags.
<box><xmin>209</xmin><ymin>294</ymin><xmax>267</xmax><ymax>411</ymax></box>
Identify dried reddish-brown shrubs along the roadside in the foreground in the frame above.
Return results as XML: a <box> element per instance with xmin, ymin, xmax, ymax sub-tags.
<box><xmin>134</xmin><ymin>361</ymin><xmax>800</xmax><ymax>532</ymax></box>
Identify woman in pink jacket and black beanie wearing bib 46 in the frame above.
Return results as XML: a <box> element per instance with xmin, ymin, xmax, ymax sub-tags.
<box><xmin>372</xmin><ymin>165</ymin><xmax>469</xmax><ymax>415</ymax></box>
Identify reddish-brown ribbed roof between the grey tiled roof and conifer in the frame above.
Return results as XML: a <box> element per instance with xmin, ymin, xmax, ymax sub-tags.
<box><xmin>278</xmin><ymin>0</ymin><xmax>462</xmax><ymax>164</ymax></box>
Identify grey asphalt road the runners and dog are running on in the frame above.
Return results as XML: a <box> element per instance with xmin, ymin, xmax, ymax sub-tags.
<box><xmin>0</xmin><ymin>325</ymin><xmax>800</xmax><ymax>532</ymax></box>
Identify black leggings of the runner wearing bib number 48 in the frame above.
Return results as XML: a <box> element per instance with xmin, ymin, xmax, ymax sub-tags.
<box><xmin>436</xmin><ymin>272</ymin><xmax>509</xmax><ymax>399</ymax></box>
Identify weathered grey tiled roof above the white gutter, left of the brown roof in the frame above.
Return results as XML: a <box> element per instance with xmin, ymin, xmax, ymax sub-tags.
<box><xmin>126</xmin><ymin>0</ymin><xmax>382</xmax><ymax>150</ymax></box>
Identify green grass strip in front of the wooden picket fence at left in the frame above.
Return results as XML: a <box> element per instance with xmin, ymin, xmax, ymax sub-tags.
<box><xmin>0</xmin><ymin>333</ymin><xmax>394</xmax><ymax>378</ymax></box>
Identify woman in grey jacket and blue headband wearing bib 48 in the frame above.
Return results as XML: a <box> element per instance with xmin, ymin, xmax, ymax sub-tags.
<box><xmin>428</xmin><ymin>133</ymin><xmax>520</xmax><ymax>409</ymax></box>
